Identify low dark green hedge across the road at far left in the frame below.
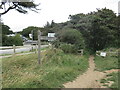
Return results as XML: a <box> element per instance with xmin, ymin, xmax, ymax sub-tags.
<box><xmin>2</xmin><ymin>34</ymin><xmax>23</xmax><ymax>46</ymax></box>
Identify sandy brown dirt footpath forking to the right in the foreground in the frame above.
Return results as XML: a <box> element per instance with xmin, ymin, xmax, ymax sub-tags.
<box><xmin>64</xmin><ymin>56</ymin><xmax>118</xmax><ymax>88</ymax></box>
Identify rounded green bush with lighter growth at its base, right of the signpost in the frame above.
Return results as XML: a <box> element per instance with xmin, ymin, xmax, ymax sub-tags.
<box><xmin>53</xmin><ymin>28</ymin><xmax>85</xmax><ymax>53</ymax></box>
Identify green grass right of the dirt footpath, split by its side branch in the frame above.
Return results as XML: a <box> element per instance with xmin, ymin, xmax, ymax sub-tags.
<box><xmin>94</xmin><ymin>49</ymin><xmax>120</xmax><ymax>88</ymax></box>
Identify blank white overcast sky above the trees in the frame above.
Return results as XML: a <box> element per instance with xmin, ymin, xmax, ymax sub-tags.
<box><xmin>2</xmin><ymin>0</ymin><xmax>120</xmax><ymax>32</ymax></box>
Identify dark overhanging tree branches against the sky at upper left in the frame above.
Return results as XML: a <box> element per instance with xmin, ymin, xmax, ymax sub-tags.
<box><xmin>0</xmin><ymin>0</ymin><xmax>39</xmax><ymax>16</ymax></box>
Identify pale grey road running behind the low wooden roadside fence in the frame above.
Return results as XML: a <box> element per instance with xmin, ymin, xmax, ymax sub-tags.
<box><xmin>0</xmin><ymin>45</ymin><xmax>48</xmax><ymax>55</ymax></box>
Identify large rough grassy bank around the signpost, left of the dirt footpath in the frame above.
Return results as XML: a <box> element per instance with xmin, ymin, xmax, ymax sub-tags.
<box><xmin>3</xmin><ymin>49</ymin><xmax>88</xmax><ymax>88</ymax></box>
